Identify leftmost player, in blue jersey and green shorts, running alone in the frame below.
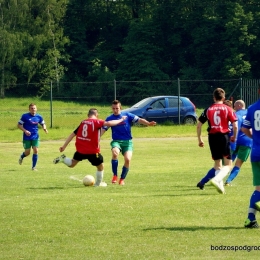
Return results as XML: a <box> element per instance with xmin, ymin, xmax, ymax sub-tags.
<box><xmin>17</xmin><ymin>103</ymin><xmax>48</xmax><ymax>171</ymax></box>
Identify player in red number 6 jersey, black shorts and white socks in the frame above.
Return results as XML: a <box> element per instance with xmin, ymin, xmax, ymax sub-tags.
<box><xmin>197</xmin><ymin>88</ymin><xmax>237</xmax><ymax>194</ymax></box>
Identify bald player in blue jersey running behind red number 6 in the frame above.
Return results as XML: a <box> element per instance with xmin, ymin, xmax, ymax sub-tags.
<box><xmin>225</xmin><ymin>100</ymin><xmax>252</xmax><ymax>186</ymax></box>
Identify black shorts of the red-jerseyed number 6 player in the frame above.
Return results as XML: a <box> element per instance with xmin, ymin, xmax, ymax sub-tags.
<box><xmin>208</xmin><ymin>133</ymin><xmax>231</xmax><ymax>160</ymax></box>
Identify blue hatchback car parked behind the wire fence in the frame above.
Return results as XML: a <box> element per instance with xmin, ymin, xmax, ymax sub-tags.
<box><xmin>122</xmin><ymin>96</ymin><xmax>197</xmax><ymax>125</ymax></box>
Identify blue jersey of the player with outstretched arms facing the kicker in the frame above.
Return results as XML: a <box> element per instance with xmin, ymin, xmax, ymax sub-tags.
<box><xmin>103</xmin><ymin>112</ymin><xmax>139</xmax><ymax>140</ymax></box>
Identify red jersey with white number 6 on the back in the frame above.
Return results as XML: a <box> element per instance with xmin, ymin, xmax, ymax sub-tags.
<box><xmin>199</xmin><ymin>104</ymin><xmax>237</xmax><ymax>134</ymax></box>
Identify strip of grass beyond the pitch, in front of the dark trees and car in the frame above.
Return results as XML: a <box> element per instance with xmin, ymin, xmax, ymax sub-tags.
<box><xmin>0</xmin><ymin>98</ymin><xmax>206</xmax><ymax>142</ymax></box>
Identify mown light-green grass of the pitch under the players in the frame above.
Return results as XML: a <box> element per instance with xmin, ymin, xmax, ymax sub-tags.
<box><xmin>0</xmin><ymin>139</ymin><xmax>259</xmax><ymax>260</ymax></box>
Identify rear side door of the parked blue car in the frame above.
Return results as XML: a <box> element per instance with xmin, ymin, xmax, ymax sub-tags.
<box><xmin>166</xmin><ymin>96</ymin><xmax>185</xmax><ymax>123</ymax></box>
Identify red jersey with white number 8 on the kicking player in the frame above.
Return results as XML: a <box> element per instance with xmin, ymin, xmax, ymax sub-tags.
<box><xmin>74</xmin><ymin>118</ymin><xmax>105</xmax><ymax>154</ymax></box>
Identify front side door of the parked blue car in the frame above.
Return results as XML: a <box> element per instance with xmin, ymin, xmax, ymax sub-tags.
<box><xmin>144</xmin><ymin>98</ymin><xmax>167</xmax><ymax>123</ymax></box>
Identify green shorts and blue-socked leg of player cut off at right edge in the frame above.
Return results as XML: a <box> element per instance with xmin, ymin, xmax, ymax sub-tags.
<box><xmin>244</xmin><ymin>162</ymin><xmax>260</xmax><ymax>228</ymax></box>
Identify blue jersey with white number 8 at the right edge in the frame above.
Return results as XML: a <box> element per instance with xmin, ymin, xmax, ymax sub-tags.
<box><xmin>242</xmin><ymin>100</ymin><xmax>260</xmax><ymax>162</ymax></box>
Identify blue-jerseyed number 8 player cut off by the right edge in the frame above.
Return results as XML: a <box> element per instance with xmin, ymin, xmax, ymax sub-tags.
<box><xmin>242</xmin><ymin>88</ymin><xmax>260</xmax><ymax>228</ymax></box>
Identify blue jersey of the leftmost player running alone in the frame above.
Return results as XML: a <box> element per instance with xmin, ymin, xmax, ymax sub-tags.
<box><xmin>18</xmin><ymin>113</ymin><xmax>45</xmax><ymax>140</ymax></box>
